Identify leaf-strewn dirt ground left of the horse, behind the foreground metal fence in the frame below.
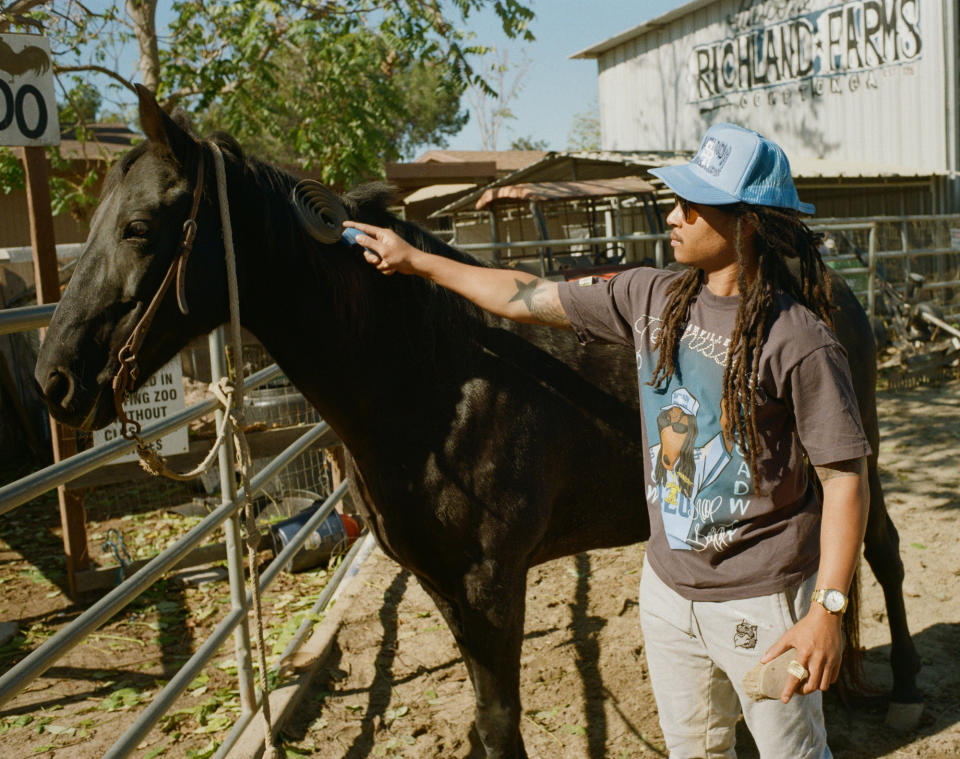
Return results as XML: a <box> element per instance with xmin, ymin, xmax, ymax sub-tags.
<box><xmin>0</xmin><ymin>481</ymin><xmax>342</xmax><ymax>759</ymax></box>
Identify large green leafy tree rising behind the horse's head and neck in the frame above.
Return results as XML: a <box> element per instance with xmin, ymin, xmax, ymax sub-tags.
<box><xmin>0</xmin><ymin>0</ymin><xmax>533</xmax><ymax>205</ymax></box>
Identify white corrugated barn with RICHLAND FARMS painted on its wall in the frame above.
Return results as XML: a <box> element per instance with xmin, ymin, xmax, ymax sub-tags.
<box><xmin>573</xmin><ymin>0</ymin><xmax>960</xmax><ymax>217</ymax></box>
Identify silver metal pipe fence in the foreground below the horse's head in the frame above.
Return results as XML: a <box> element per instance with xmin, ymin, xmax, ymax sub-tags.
<box><xmin>0</xmin><ymin>304</ymin><xmax>373</xmax><ymax>759</ymax></box>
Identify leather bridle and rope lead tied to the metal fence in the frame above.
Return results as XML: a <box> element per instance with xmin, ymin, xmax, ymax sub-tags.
<box><xmin>113</xmin><ymin>142</ymin><xmax>281</xmax><ymax>759</ymax></box>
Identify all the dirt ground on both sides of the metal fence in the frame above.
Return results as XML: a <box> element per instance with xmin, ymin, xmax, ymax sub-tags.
<box><xmin>0</xmin><ymin>381</ymin><xmax>960</xmax><ymax>759</ymax></box>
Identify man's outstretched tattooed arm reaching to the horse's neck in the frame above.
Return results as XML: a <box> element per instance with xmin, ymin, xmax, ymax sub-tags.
<box><xmin>344</xmin><ymin>221</ymin><xmax>570</xmax><ymax>329</ymax></box>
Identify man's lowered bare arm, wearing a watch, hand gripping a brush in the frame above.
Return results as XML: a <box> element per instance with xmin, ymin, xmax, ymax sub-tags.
<box><xmin>762</xmin><ymin>458</ymin><xmax>870</xmax><ymax>702</ymax></box>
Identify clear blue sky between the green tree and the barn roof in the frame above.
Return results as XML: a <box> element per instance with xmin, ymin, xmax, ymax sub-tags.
<box><xmin>448</xmin><ymin>0</ymin><xmax>686</xmax><ymax>150</ymax></box>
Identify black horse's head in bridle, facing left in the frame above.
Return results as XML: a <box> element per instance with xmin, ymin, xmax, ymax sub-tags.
<box><xmin>35</xmin><ymin>87</ymin><xmax>226</xmax><ymax>429</ymax></box>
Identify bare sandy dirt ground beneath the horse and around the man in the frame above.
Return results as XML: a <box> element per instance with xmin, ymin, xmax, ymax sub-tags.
<box><xmin>287</xmin><ymin>381</ymin><xmax>960</xmax><ymax>759</ymax></box>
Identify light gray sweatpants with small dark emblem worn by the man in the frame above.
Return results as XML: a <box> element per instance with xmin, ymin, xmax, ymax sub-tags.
<box><xmin>640</xmin><ymin>558</ymin><xmax>831</xmax><ymax>759</ymax></box>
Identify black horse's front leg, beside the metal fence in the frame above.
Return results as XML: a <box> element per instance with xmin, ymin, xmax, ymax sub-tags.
<box><xmin>422</xmin><ymin>561</ymin><xmax>527</xmax><ymax>759</ymax></box>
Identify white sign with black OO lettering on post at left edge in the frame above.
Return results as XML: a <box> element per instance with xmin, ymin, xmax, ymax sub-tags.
<box><xmin>0</xmin><ymin>34</ymin><xmax>60</xmax><ymax>146</ymax></box>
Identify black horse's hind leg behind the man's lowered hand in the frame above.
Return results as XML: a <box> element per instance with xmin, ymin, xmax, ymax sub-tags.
<box><xmin>863</xmin><ymin>464</ymin><xmax>923</xmax><ymax>704</ymax></box>
